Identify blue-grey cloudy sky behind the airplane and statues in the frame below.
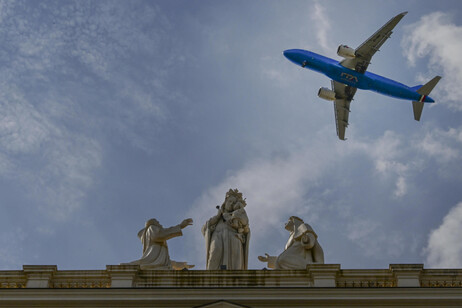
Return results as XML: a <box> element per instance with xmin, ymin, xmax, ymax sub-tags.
<box><xmin>0</xmin><ymin>0</ymin><xmax>462</xmax><ymax>269</ymax></box>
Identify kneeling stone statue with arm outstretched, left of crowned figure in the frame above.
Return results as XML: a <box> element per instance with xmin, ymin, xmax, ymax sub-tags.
<box><xmin>122</xmin><ymin>218</ymin><xmax>194</xmax><ymax>270</ymax></box>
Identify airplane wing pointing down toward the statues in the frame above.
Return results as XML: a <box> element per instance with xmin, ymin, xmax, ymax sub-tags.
<box><xmin>332</xmin><ymin>80</ymin><xmax>356</xmax><ymax>140</ymax></box>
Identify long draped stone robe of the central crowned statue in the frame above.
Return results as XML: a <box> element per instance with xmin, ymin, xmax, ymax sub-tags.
<box><xmin>202</xmin><ymin>211</ymin><xmax>250</xmax><ymax>270</ymax></box>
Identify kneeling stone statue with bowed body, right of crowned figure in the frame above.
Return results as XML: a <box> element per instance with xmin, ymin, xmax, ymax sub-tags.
<box><xmin>258</xmin><ymin>216</ymin><xmax>324</xmax><ymax>269</ymax></box>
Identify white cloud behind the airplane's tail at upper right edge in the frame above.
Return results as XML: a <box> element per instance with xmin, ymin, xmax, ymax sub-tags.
<box><xmin>402</xmin><ymin>12</ymin><xmax>462</xmax><ymax>111</ymax></box>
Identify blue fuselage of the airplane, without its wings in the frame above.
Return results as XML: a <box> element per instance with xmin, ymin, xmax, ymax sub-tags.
<box><xmin>284</xmin><ymin>49</ymin><xmax>435</xmax><ymax>103</ymax></box>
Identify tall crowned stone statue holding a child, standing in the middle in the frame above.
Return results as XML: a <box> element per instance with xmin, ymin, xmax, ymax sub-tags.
<box><xmin>202</xmin><ymin>189</ymin><xmax>250</xmax><ymax>270</ymax></box>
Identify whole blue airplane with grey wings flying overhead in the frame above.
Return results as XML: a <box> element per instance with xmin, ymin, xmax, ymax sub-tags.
<box><xmin>283</xmin><ymin>12</ymin><xmax>441</xmax><ymax>140</ymax></box>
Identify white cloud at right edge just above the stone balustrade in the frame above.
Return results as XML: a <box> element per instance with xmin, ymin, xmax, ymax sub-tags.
<box><xmin>424</xmin><ymin>202</ymin><xmax>462</xmax><ymax>268</ymax></box>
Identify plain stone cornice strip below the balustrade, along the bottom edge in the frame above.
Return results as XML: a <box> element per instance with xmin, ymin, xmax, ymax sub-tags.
<box><xmin>0</xmin><ymin>287</ymin><xmax>462</xmax><ymax>307</ymax></box>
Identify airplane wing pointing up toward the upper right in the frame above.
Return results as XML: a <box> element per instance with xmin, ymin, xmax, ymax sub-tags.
<box><xmin>340</xmin><ymin>12</ymin><xmax>407</xmax><ymax>73</ymax></box>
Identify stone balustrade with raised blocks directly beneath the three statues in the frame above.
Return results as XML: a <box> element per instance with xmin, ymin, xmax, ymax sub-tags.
<box><xmin>0</xmin><ymin>264</ymin><xmax>462</xmax><ymax>288</ymax></box>
